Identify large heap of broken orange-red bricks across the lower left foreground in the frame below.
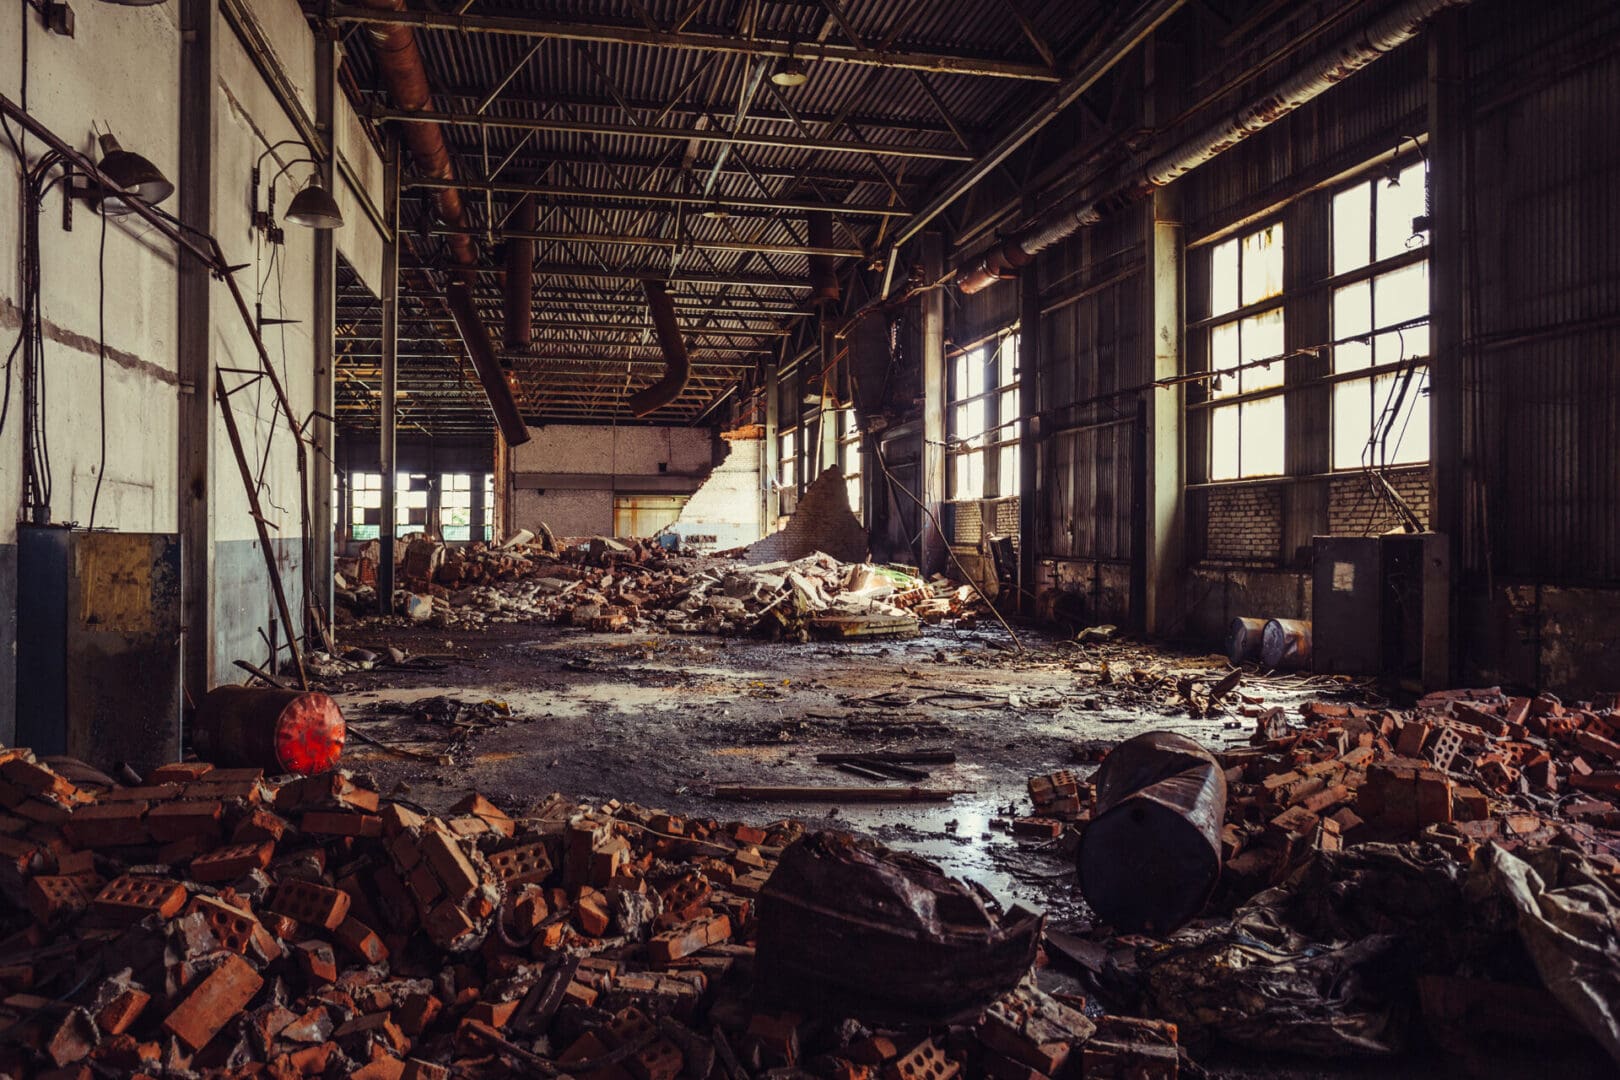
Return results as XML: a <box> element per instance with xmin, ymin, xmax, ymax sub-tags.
<box><xmin>0</xmin><ymin>750</ymin><xmax>1179</xmax><ymax>1080</ymax></box>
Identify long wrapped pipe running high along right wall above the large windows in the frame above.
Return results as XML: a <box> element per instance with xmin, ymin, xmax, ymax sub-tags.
<box><xmin>957</xmin><ymin>0</ymin><xmax>1469</xmax><ymax>293</ymax></box>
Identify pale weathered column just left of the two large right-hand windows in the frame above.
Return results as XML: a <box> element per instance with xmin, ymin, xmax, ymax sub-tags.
<box><xmin>1132</xmin><ymin>188</ymin><xmax>1186</xmax><ymax>633</ymax></box>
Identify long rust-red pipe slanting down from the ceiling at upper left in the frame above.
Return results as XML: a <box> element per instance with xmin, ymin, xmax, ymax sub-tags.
<box><xmin>361</xmin><ymin>0</ymin><xmax>533</xmax><ymax>445</ymax></box>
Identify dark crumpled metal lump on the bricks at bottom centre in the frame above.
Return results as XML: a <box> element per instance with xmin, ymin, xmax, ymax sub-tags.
<box><xmin>755</xmin><ymin>832</ymin><xmax>1043</xmax><ymax>1022</ymax></box>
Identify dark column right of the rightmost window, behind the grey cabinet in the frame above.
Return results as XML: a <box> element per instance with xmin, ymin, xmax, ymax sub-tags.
<box><xmin>1424</xmin><ymin>11</ymin><xmax>1471</xmax><ymax>687</ymax></box>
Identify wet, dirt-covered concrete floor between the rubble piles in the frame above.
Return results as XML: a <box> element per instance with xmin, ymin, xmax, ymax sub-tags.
<box><xmin>315</xmin><ymin>627</ymin><xmax>1354</xmax><ymax>925</ymax></box>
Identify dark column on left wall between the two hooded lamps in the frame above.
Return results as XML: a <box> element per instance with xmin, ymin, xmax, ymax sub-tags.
<box><xmin>177</xmin><ymin>0</ymin><xmax>219</xmax><ymax>701</ymax></box>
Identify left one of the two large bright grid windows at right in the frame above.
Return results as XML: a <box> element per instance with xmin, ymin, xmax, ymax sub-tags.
<box><xmin>1209</xmin><ymin>223</ymin><xmax>1286</xmax><ymax>481</ymax></box>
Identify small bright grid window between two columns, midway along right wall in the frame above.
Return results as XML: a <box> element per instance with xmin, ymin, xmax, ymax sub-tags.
<box><xmin>946</xmin><ymin>334</ymin><xmax>1019</xmax><ymax>499</ymax></box>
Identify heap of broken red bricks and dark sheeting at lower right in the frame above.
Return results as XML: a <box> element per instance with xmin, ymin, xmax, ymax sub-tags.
<box><xmin>1011</xmin><ymin>688</ymin><xmax>1620</xmax><ymax>1072</ymax></box>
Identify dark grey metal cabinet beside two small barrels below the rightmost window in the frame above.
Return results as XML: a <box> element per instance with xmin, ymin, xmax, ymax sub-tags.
<box><xmin>1311</xmin><ymin>533</ymin><xmax>1450</xmax><ymax>690</ymax></box>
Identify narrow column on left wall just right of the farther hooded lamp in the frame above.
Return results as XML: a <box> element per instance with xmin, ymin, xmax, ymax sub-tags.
<box><xmin>309</xmin><ymin>31</ymin><xmax>337</xmax><ymax>641</ymax></box>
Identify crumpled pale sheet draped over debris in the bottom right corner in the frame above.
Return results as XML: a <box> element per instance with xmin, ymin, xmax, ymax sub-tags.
<box><xmin>1481</xmin><ymin>845</ymin><xmax>1620</xmax><ymax>1062</ymax></box>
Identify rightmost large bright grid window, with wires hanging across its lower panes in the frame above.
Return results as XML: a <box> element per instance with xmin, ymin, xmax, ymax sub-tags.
<box><xmin>1333</xmin><ymin>160</ymin><xmax>1429</xmax><ymax>468</ymax></box>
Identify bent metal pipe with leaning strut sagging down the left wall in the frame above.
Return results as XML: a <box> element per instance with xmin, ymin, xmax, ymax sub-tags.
<box><xmin>0</xmin><ymin>94</ymin><xmax>329</xmax><ymax>688</ymax></box>
